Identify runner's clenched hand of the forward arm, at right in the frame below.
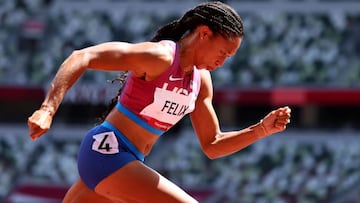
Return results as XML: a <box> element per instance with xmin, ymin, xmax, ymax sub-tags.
<box><xmin>261</xmin><ymin>106</ymin><xmax>291</xmax><ymax>136</ymax></box>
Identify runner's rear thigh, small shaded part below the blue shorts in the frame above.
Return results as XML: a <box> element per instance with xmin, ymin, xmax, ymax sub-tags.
<box><xmin>62</xmin><ymin>179</ymin><xmax>115</xmax><ymax>203</ymax></box>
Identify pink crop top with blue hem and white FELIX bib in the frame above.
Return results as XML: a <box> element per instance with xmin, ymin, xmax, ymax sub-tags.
<box><xmin>118</xmin><ymin>41</ymin><xmax>200</xmax><ymax>131</ymax></box>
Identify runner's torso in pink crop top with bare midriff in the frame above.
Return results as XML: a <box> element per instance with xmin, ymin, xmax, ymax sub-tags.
<box><xmin>106</xmin><ymin>41</ymin><xmax>200</xmax><ymax>155</ymax></box>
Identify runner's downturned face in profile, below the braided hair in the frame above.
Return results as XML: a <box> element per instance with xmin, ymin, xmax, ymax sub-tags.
<box><xmin>195</xmin><ymin>26</ymin><xmax>242</xmax><ymax>70</ymax></box>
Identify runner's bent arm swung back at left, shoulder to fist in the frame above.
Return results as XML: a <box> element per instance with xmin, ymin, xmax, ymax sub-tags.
<box><xmin>28</xmin><ymin>42</ymin><xmax>173</xmax><ymax>140</ymax></box>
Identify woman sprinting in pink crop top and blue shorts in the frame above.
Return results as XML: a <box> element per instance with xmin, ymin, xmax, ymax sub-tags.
<box><xmin>28</xmin><ymin>2</ymin><xmax>290</xmax><ymax>203</ymax></box>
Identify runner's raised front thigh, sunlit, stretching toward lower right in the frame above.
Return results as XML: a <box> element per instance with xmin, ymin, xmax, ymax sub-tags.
<box><xmin>95</xmin><ymin>161</ymin><xmax>197</xmax><ymax>203</ymax></box>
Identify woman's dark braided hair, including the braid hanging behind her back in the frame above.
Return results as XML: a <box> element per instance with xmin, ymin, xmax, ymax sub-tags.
<box><xmin>97</xmin><ymin>1</ymin><xmax>244</xmax><ymax>124</ymax></box>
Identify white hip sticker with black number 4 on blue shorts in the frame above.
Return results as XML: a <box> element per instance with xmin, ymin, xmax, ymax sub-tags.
<box><xmin>92</xmin><ymin>132</ymin><xmax>119</xmax><ymax>154</ymax></box>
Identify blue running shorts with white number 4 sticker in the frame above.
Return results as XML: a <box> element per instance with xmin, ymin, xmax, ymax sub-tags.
<box><xmin>78</xmin><ymin>121</ymin><xmax>145</xmax><ymax>190</ymax></box>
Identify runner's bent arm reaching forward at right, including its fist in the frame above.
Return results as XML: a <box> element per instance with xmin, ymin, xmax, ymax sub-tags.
<box><xmin>190</xmin><ymin>70</ymin><xmax>291</xmax><ymax>159</ymax></box>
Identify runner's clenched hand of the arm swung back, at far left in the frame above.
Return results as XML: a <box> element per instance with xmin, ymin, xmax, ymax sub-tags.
<box><xmin>28</xmin><ymin>109</ymin><xmax>53</xmax><ymax>140</ymax></box>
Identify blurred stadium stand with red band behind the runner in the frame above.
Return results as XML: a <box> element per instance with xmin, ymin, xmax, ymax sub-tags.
<box><xmin>0</xmin><ymin>0</ymin><xmax>360</xmax><ymax>203</ymax></box>
